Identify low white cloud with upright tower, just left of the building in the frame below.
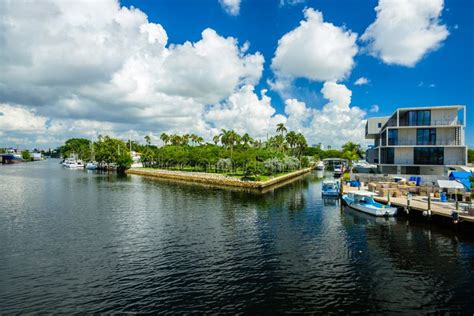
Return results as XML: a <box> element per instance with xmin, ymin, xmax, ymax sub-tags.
<box><xmin>285</xmin><ymin>81</ymin><xmax>366</xmax><ymax>146</ymax></box>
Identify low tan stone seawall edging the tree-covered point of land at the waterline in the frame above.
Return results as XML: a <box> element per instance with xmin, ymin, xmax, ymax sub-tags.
<box><xmin>125</xmin><ymin>168</ymin><xmax>313</xmax><ymax>190</ymax></box>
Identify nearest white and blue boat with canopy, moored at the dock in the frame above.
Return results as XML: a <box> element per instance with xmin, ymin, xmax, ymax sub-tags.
<box><xmin>342</xmin><ymin>190</ymin><xmax>397</xmax><ymax>216</ymax></box>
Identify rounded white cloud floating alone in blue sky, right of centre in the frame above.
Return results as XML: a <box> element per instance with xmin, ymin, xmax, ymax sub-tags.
<box><xmin>271</xmin><ymin>8</ymin><xmax>357</xmax><ymax>81</ymax></box>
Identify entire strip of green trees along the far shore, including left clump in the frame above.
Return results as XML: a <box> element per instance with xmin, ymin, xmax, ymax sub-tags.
<box><xmin>60</xmin><ymin>124</ymin><xmax>362</xmax><ymax>181</ymax></box>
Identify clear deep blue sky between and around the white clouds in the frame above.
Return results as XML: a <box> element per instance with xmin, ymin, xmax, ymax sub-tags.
<box><xmin>126</xmin><ymin>0</ymin><xmax>474</xmax><ymax>142</ymax></box>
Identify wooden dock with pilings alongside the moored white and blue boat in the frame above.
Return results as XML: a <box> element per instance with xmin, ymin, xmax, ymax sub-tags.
<box><xmin>343</xmin><ymin>185</ymin><xmax>474</xmax><ymax>223</ymax></box>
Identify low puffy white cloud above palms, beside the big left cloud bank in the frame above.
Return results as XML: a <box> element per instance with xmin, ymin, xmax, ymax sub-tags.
<box><xmin>205</xmin><ymin>85</ymin><xmax>286</xmax><ymax>138</ymax></box>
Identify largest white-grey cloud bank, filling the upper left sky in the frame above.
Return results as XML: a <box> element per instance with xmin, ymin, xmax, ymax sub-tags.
<box><xmin>0</xmin><ymin>0</ymin><xmax>264</xmax><ymax>146</ymax></box>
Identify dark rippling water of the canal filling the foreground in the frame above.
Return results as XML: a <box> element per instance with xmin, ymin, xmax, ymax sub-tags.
<box><xmin>0</xmin><ymin>160</ymin><xmax>474</xmax><ymax>314</ymax></box>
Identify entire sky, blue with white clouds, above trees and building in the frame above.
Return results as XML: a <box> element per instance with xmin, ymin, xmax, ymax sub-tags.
<box><xmin>0</xmin><ymin>0</ymin><xmax>474</xmax><ymax>149</ymax></box>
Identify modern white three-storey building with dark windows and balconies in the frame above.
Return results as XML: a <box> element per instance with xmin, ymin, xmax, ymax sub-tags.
<box><xmin>365</xmin><ymin>105</ymin><xmax>467</xmax><ymax>175</ymax></box>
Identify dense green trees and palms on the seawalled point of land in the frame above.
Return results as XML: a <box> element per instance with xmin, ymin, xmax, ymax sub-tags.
<box><xmin>135</xmin><ymin>125</ymin><xmax>310</xmax><ymax>181</ymax></box>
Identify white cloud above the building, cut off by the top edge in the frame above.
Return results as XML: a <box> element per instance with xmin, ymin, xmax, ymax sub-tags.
<box><xmin>361</xmin><ymin>0</ymin><xmax>449</xmax><ymax>67</ymax></box>
